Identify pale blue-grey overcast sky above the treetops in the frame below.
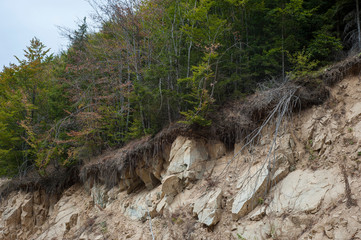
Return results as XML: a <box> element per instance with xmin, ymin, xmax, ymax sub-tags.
<box><xmin>0</xmin><ymin>0</ymin><xmax>93</xmax><ymax>68</ymax></box>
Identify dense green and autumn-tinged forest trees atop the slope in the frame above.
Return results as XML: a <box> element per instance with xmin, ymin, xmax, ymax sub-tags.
<box><xmin>0</xmin><ymin>0</ymin><xmax>361</xmax><ymax>176</ymax></box>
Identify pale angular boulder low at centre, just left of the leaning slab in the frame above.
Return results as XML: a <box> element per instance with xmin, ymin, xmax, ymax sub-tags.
<box><xmin>193</xmin><ymin>189</ymin><xmax>222</xmax><ymax>226</ymax></box>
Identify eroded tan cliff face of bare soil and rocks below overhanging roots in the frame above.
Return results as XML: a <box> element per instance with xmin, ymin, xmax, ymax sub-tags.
<box><xmin>0</xmin><ymin>78</ymin><xmax>361</xmax><ymax>240</ymax></box>
